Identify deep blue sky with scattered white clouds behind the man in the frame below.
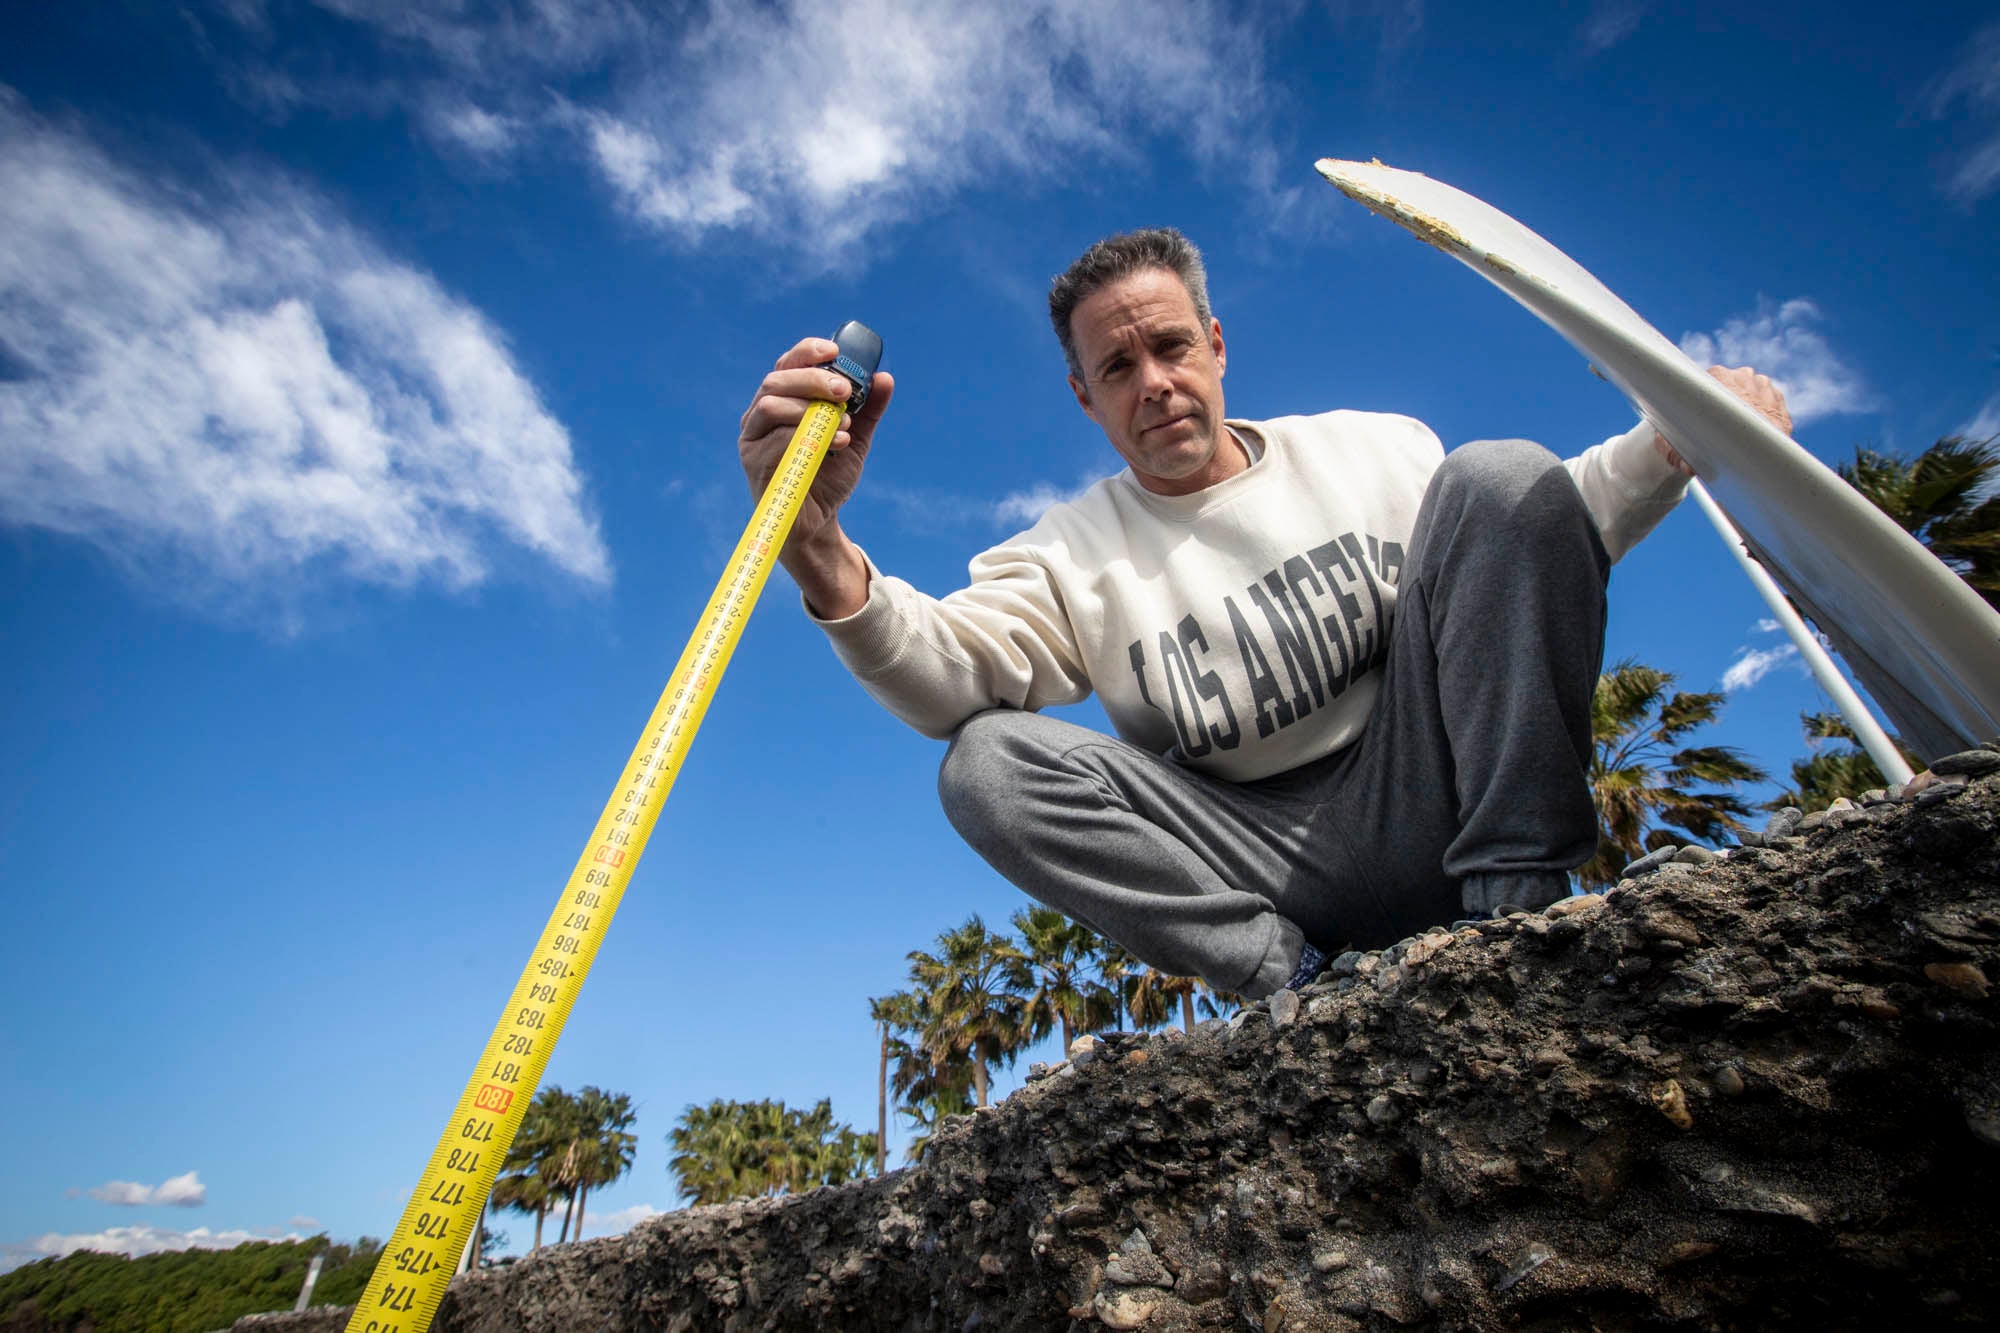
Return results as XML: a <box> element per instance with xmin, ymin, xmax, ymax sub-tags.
<box><xmin>0</xmin><ymin>0</ymin><xmax>2000</xmax><ymax>1265</ymax></box>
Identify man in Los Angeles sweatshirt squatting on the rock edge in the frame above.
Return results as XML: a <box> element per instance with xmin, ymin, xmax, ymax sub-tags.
<box><xmin>740</xmin><ymin>230</ymin><xmax>1790</xmax><ymax>997</ymax></box>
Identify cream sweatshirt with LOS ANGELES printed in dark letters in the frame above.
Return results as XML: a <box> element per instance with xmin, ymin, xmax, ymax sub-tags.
<box><xmin>808</xmin><ymin>412</ymin><xmax>1686</xmax><ymax>781</ymax></box>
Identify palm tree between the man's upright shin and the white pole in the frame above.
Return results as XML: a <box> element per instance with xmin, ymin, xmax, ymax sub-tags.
<box><xmin>1576</xmin><ymin>658</ymin><xmax>1766</xmax><ymax>885</ymax></box>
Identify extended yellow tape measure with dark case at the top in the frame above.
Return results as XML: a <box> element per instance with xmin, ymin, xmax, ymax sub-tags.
<box><xmin>348</xmin><ymin>322</ymin><xmax>882</xmax><ymax>1333</ymax></box>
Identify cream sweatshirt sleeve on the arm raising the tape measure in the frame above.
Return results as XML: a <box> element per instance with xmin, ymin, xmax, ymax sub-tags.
<box><xmin>806</xmin><ymin>544</ymin><xmax>1090</xmax><ymax>739</ymax></box>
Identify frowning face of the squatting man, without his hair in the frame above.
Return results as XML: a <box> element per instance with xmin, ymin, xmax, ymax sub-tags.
<box><xmin>1070</xmin><ymin>268</ymin><xmax>1246</xmax><ymax>494</ymax></box>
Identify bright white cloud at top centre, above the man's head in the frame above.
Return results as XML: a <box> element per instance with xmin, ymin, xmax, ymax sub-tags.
<box><xmin>576</xmin><ymin>0</ymin><xmax>1284</xmax><ymax>254</ymax></box>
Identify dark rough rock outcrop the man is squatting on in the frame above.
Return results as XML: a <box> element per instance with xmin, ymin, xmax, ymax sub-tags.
<box><xmin>250</xmin><ymin>761</ymin><xmax>2000</xmax><ymax>1333</ymax></box>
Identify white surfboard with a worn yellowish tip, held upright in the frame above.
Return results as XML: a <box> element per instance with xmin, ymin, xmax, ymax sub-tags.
<box><xmin>1316</xmin><ymin>158</ymin><xmax>2000</xmax><ymax>757</ymax></box>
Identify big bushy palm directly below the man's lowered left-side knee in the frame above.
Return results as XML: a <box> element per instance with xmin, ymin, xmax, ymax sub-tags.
<box><xmin>910</xmin><ymin>913</ymin><xmax>1030</xmax><ymax>1107</ymax></box>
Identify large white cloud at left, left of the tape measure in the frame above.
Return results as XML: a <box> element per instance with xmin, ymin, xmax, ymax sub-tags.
<box><xmin>0</xmin><ymin>88</ymin><xmax>610</xmax><ymax>608</ymax></box>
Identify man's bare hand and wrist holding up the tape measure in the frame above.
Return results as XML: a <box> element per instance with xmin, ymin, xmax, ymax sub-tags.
<box><xmin>736</xmin><ymin>338</ymin><xmax>896</xmax><ymax>620</ymax></box>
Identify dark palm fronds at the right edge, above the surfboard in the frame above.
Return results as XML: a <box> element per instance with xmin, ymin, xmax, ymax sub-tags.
<box><xmin>1834</xmin><ymin>434</ymin><xmax>2000</xmax><ymax>606</ymax></box>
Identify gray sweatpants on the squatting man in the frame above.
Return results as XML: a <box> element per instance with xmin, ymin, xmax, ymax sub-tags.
<box><xmin>938</xmin><ymin>440</ymin><xmax>1610</xmax><ymax>997</ymax></box>
